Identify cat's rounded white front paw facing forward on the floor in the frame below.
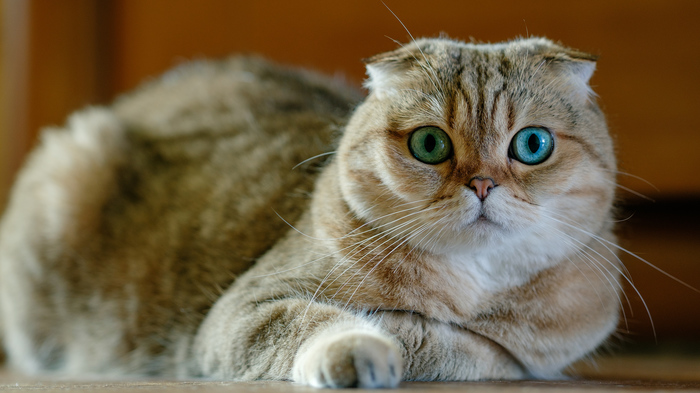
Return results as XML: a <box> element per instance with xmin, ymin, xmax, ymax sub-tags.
<box><xmin>294</xmin><ymin>330</ymin><xmax>403</xmax><ymax>388</ymax></box>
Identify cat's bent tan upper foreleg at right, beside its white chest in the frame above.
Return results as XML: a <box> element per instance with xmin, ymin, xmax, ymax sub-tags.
<box><xmin>467</xmin><ymin>242</ymin><xmax>622</xmax><ymax>378</ymax></box>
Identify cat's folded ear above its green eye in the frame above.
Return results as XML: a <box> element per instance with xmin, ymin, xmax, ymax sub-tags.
<box><xmin>363</xmin><ymin>48</ymin><xmax>415</xmax><ymax>96</ymax></box>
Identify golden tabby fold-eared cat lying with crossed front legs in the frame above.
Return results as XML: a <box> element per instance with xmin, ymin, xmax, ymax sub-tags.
<box><xmin>0</xmin><ymin>38</ymin><xmax>622</xmax><ymax>388</ymax></box>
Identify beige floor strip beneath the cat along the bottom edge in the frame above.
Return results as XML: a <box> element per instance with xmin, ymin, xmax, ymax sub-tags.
<box><xmin>0</xmin><ymin>351</ymin><xmax>700</xmax><ymax>393</ymax></box>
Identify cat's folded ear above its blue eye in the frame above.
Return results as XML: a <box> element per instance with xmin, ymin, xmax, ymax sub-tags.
<box><xmin>545</xmin><ymin>49</ymin><xmax>598</xmax><ymax>101</ymax></box>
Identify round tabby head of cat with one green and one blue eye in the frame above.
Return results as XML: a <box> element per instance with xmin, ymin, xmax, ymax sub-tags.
<box><xmin>337</xmin><ymin>38</ymin><xmax>616</xmax><ymax>262</ymax></box>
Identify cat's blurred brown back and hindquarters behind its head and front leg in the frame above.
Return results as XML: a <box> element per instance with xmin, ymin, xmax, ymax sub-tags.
<box><xmin>0</xmin><ymin>57</ymin><xmax>360</xmax><ymax>371</ymax></box>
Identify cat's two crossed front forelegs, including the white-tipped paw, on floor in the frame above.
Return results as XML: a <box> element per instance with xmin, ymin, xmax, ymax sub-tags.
<box><xmin>194</xmin><ymin>293</ymin><xmax>528</xmax><ymax>388</ymax></box>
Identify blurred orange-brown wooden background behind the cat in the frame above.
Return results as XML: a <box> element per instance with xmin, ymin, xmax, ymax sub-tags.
<box><xmin>0</xmin><ymin>0</ymin><xmax>700</xmax><ymax>343</ymax></box>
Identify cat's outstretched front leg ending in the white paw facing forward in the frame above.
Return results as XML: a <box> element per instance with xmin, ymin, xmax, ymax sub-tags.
<box><xmin>194</xmin><ymin>292</ymin><xmax>402</xmax><ymax>388</ymax></box>
